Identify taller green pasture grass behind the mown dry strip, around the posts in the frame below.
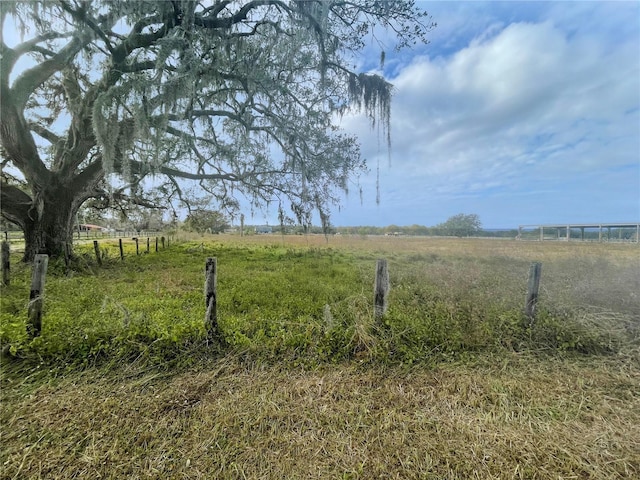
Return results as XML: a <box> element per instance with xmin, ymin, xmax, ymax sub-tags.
<box><xmin>0</xmin><ymin>237</ymin><xmax>640</xmax><ymax>365</ymax></box>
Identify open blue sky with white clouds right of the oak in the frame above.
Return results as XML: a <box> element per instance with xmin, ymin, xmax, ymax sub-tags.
<box><xmin>316</xmin><ymin>1</ymin><xmax>640</xmax><ymax>228</ymax></box>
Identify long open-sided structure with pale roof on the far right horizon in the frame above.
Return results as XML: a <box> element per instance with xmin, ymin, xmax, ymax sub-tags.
<box><xmin>516</xmin><ymin>222</ymin><xmax>640</xmax><ymax>243</ymax></box>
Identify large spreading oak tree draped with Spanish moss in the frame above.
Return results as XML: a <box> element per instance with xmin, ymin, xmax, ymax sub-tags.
<box><xmin>0</xmin><ymin>0</ymin><xmax>432</xmax><ymax>260</ymax></box>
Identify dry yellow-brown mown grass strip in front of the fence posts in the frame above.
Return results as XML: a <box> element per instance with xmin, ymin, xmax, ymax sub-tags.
<box><xmin>1</xmin><ymin>354</ymin><xmax>640</xmax><ymax>479</ymax></box>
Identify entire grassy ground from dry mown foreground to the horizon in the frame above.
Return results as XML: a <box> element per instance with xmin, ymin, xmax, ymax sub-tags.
<box><xmin>0</xmin><ymin>235</ymin><xmax>640</xmax><ymax>479</ymax></box>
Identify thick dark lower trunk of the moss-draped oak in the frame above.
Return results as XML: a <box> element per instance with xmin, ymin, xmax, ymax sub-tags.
<box><xmin>23</xmin><ymin>188</ymin><xmax>77</xmax><ymax>262</ymax></box>
